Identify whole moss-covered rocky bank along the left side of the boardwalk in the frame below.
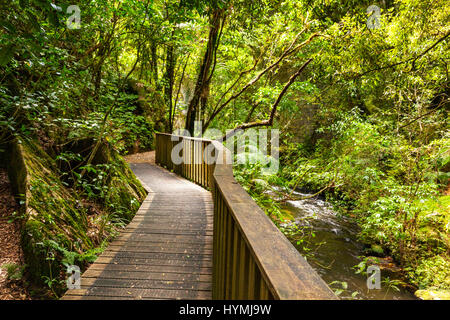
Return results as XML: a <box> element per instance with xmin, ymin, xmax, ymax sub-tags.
<box><xmin>4</xmin><ymin>138</ymin><xmax>146</xmax><ymax>295</ymax></box>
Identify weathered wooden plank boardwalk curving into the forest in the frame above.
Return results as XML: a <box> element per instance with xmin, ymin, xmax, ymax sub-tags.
<box><xmin>63</xmin><ymin>163</ymin><xmax>213</xmax><ymax>300</ymax></box>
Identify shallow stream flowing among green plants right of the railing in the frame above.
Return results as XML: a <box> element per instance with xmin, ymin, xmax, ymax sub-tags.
<box><xmin>282</xmin><ymin>192</ymin><xmax>415</xmax><ymax>300</ymax></box>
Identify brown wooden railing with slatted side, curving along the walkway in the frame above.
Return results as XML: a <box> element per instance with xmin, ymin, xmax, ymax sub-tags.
<box><xmin>156</xmin><ymin>133</ymin><xmax>337</xmax><ymax>299</ymax></box>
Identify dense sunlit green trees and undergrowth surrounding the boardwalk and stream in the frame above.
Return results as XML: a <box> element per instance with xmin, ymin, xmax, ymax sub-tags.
<box><xmin>0</xmin><ymin>0</ymin><xmax>450</xmax><ymax>298</ymax></box>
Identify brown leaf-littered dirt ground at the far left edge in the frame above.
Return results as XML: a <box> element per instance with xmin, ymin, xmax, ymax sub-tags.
<box><xmin>0</xmin><ymin>169</ymin><xmax>30</xmax><ymax>300</ymax></box>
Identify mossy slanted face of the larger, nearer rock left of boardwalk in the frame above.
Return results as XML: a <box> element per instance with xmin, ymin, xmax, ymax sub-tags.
<box><xmin>22</xmin><ymin>139</ymin><xmax>94</xmax><ymax>283</ymax></box>
